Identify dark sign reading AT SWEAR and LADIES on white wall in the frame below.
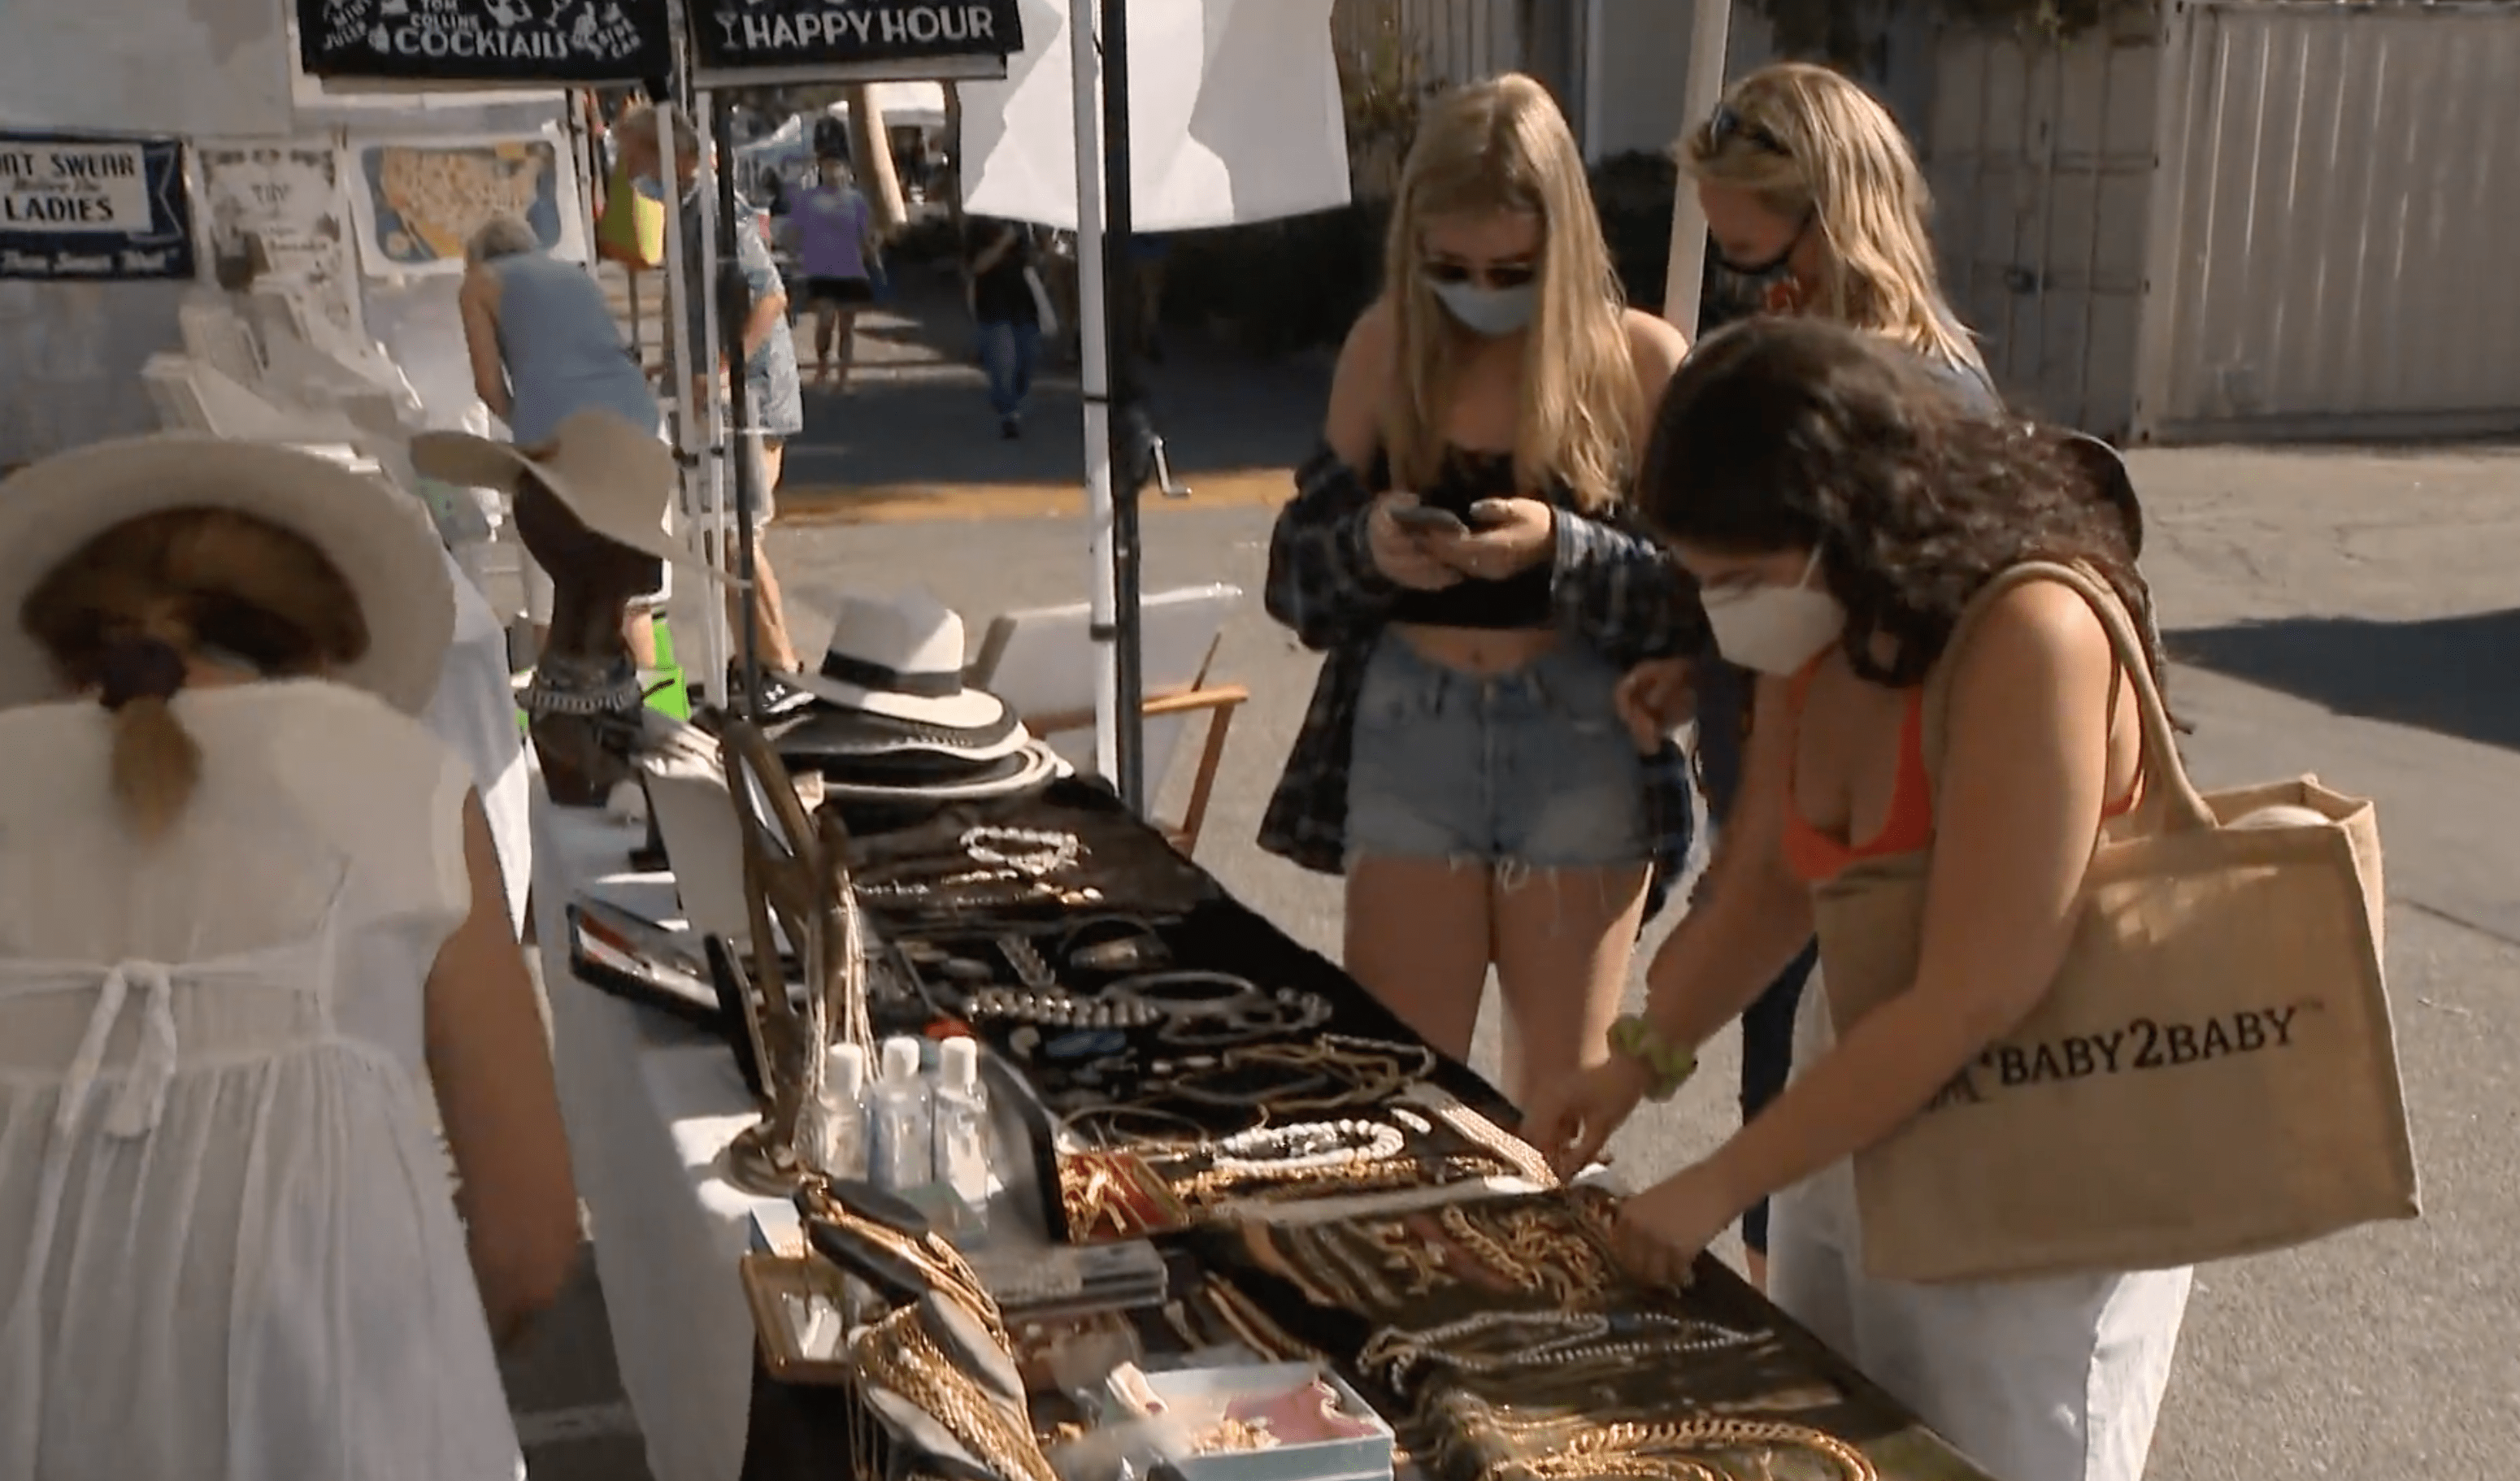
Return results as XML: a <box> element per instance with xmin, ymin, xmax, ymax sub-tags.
<box><xmin>0</xmin><ymin>133</ymin><xmax>194</xmax><ymax>282</ymax></box>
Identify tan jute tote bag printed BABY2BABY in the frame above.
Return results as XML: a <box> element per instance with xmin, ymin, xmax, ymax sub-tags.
<box><xmin>1814</xmin><ymin>564</ymin><xmax>2417</xmax><ymax>1282</ymax></box>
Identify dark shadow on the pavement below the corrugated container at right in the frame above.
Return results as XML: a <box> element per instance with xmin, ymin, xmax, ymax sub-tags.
<box><xmin>2165</xmin><ymin>610</ymin><xmax>2520</xmax><ymax>750</ymax></box>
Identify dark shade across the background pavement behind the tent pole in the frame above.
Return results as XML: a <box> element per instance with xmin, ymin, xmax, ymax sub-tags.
<box><xmin>779</xmin><ymin>270</ymin><xmax>1331</xmax><ymax>516</ymax></box>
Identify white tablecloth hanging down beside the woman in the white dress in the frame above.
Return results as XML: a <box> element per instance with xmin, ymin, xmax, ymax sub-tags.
<box><xmin>534</xmin><ymin>793</ymin><xmax>786</xmax><ymax>1481</ymax></box>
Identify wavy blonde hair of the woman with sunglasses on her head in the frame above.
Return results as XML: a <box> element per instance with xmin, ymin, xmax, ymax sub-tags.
<box><xmin>1681</xmin><ymin>63</ymin><xmax>1986</xmax><ymax>371</ymax></box>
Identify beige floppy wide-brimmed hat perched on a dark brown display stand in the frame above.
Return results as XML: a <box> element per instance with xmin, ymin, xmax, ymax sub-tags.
<box><xmin>411</xmin><ymin>406</ymin><xmax>726</xmax><ymax>580</ymax></box>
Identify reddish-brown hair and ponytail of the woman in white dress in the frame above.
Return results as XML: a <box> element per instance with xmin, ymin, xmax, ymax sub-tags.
<box><xmin>18</xmin><ymin>509</ymin><xmax>368</xmax><ymax>839</ymax></box>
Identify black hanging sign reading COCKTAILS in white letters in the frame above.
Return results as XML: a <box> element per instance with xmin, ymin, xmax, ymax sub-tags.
<box><xmin>298</xmin><ymin>0</ymin><xmax>673</xmax><ymax>85</ymax></box>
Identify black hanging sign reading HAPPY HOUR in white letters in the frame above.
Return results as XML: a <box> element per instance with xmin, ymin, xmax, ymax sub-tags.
<box><xmin>690</xmin><ymin>0</ymin><xmax>1023</xmax><ymax>78</ymax></box>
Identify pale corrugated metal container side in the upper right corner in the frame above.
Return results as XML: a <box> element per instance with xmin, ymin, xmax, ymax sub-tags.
<box><xmin>2140</xmin><ymin>0</ymin><xmax>2520</xmax><ymax>438</ymax></box>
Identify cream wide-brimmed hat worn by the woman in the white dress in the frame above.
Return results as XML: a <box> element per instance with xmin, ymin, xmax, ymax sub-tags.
<box><xmin>0</xmin><ymin>433</ymin><xmax>456</xmax><ymax>715</ymax></box>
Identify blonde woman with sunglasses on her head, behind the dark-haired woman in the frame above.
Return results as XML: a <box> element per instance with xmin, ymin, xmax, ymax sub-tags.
<box><xmin>1620</xmin><ymin>63</ymin><xmax>1998</xmax><ymax>1284</ymax></box>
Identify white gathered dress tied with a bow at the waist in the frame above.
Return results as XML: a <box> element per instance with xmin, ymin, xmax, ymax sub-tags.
<box><xmin>0</xmin><ymin>683</ymin><xmax>522</xmax><ymax>1481</ymax></box>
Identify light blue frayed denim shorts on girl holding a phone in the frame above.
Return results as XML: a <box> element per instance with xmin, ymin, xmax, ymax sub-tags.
<box><xmin>1349</xmin><ymin>632</ymin><xmax>1651</xmax><ymax>869</ymax></box>
